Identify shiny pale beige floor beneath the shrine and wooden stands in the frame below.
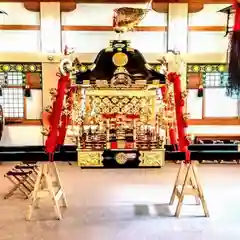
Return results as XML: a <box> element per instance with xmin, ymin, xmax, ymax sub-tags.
<box><xmin>0</xmin><ymin>161</ymin><xmax>240</xmax><ymax>240</ymax></box>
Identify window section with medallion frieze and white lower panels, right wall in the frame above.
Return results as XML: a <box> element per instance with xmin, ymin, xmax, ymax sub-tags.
<box><xmin>188</xmin><ymin>64</ymin><xmax>239</xmax><ymax>119</ymax></box>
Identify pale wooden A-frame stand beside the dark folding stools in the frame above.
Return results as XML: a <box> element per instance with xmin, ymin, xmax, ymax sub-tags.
<box><xmin>26</xmin><ymin>162</ymin><xmax>67</xmax><ymax>220</ymax></box>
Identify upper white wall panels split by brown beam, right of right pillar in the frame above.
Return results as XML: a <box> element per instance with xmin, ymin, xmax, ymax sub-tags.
<box><xmin>188</xmin><ymin>4</ymin><xmax>229</xmax><ymax>53</ymax></box>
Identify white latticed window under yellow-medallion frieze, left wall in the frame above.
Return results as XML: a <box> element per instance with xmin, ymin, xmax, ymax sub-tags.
<box><xmin>0</xmin><ymin>64</ymin><xmax>41</xmax><ymax>120</ymax></box>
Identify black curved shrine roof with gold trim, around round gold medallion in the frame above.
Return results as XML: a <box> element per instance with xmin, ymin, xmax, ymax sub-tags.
<box><xmin>76</xmin><ymin>40</ymin><xmax>165</xmax><ymax>84</ymax></box>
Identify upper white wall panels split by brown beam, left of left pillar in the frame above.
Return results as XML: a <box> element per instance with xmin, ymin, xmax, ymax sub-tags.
<box><xmin>0</xmin><ymin>3</ymin><xmax>40</xmax><ymax>52</ymax></box>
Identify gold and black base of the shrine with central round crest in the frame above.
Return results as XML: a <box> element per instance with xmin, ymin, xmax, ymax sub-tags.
<box><xmin>77</xmin><ymin>149</ymin><xmax>165</xmax><ymax>168</ymax></box>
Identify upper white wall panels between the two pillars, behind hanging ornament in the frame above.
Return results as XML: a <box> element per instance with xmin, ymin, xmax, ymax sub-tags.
<box><xmin>62</xmin><ymin>4</ymin><xmax>167</xmax><ymax>54</ymax></box>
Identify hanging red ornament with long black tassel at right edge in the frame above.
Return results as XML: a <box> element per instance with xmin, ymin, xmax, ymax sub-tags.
<box><xmin>219</xmin><ymin>0</ymin><xmax>240</xmax><ymax>99</ymax></box>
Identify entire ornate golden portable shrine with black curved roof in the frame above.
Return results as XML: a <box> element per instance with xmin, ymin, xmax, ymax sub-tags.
<box><xmin>68</xmin><ymin>40</ymin><xmax>166</xmax><ymax>167</ymax></box>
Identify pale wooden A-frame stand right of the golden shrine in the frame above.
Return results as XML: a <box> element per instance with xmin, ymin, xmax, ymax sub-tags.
<box><xmin>170</xmin><ymin>162</ymin><xmax>209</xmax><ymax>217</ymax></box>
